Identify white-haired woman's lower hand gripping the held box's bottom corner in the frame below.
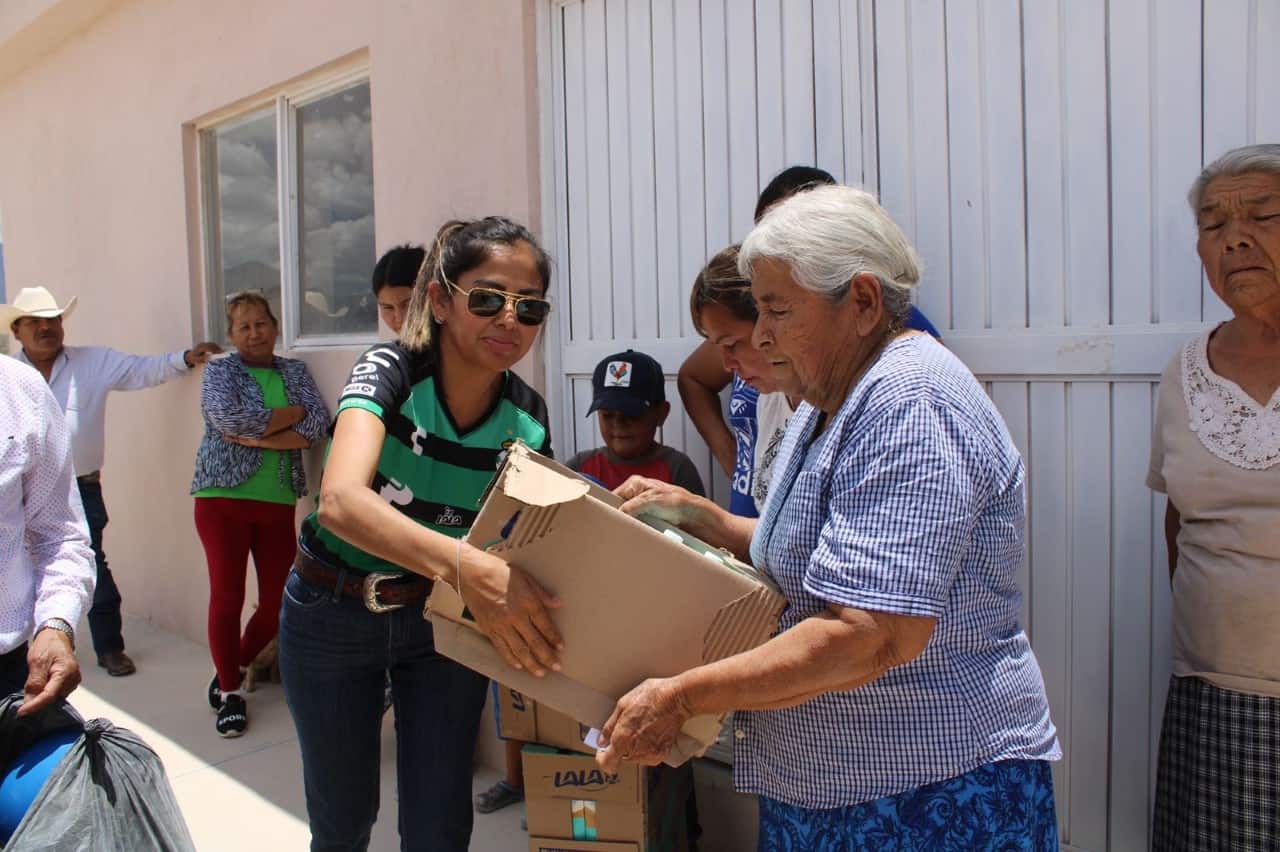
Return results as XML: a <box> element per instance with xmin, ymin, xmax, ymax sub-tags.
<box><xmin>595</xmin><ymin>678</ymin><xmax>692</xmax><ymax>773</ymax></box>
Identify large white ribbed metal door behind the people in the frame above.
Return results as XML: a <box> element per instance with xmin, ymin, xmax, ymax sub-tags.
<box><xmin>539</xmin><ymin>0</ymin><xmax>1280</xmax><ymax>851</ymax></box>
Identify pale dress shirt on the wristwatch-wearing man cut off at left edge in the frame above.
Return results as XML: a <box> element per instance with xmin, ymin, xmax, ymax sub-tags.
<box><xmin>0</xmin><ymin>356</ymin><xmax>96</xmax><ymax>652</ymax></box>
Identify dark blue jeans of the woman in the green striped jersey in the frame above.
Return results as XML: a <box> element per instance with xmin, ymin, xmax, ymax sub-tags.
<box><xmin>280</xmin><ymin>562</ymin><xmax>489</xmax><ymax>852</ymax></box>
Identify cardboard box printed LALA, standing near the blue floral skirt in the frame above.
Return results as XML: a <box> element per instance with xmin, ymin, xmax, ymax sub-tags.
<box><xmin>524</xmin><ymin>746</ymin><xmax>692</xmax><ymax>852</ymax></box>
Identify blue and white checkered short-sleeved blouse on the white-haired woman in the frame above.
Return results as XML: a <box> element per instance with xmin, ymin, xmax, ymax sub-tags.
<box><xmin>733</xmin><ymin>335</ymin><xmax>1061</xmax><ymax>809</ymax></box>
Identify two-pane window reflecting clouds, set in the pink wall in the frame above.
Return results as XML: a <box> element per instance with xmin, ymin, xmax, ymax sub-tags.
<box><xmin>200</xmin><ymin>73</ymin><xmax>378</xmax><ymax>348</ymax></box>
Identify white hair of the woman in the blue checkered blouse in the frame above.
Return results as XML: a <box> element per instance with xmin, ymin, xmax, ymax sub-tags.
<box><xmin>737</xmin><ymin>185</ymin><xmax>920</xmax><ymax>322</ymax></box>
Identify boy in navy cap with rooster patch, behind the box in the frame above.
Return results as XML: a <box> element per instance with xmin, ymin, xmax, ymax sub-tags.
<box><xmin>568</xmin><ymin>349</ymin><xmax>704</xmax><ymax>496</ymax></box>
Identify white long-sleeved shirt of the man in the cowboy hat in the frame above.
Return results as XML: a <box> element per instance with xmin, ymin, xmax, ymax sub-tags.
<box><xmin>14</xmin><ymin>347</ymin><xmax>187</xmax><ymax>476</ymax></box>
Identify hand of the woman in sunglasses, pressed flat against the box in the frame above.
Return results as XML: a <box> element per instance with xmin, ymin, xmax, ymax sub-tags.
<box><xmin>458</xmin><ymin>545</ymin><xmax>564</xmax><ymax>677</ymax></box>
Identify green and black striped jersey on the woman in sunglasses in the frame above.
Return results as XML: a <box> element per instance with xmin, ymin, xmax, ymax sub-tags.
<box><xmin>301</xmin><ymin>342</ymin><xmax>550</xmax><ymax>573</ymax></box>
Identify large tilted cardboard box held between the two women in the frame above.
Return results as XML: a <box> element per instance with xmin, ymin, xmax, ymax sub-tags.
<box><xmin>430</xmin><ymin>441</ymin><xmax>786</xmax><ymax>766</ymax></box>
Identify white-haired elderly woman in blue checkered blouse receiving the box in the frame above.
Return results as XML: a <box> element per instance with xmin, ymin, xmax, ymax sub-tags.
<box><xmin>598</xmin><ymin>187</ymin><xmax>1061</xmax><ymax>852</ymax></box>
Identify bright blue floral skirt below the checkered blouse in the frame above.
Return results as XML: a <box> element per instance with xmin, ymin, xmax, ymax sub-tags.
<box><xmin>759</xmin><ymin>760</ymin><xmax>1059</xmax><ymax>852</ymax></box>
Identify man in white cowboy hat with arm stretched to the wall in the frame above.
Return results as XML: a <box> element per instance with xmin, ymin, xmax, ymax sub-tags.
<box><xmin>0</xmin><ymin>287</ymin><xmax>221</xmax><ymax>677</ymax></box>
